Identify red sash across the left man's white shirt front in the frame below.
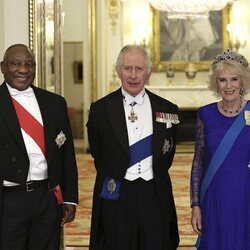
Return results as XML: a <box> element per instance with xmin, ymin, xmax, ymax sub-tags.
<box><xmin>12</xmin><ymin>98</ymin><xmax>45</xmax><ymax>156</ymax></box>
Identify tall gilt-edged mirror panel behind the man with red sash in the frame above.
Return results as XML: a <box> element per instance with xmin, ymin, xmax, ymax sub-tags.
<box><xmin>29</xmin><ymin>0</ymin><xmax>62</xmax><ymax>94</ymax></box>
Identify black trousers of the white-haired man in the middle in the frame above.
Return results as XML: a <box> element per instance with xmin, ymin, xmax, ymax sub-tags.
<box><xmin>101</xmin><ymin>179</ymin><xmax>163</xmax><ymax>250</ymax></box>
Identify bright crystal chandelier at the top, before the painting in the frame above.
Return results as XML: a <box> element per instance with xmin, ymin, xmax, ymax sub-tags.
<box><xmin>149</xmin><ymin>0</ymin><xmax>237</xmax><ymax>19</ymax></box>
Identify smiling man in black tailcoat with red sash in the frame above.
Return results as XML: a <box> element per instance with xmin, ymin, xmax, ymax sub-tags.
<box><xmin>0</xmin><ymin>44</ymin><xmax>78</xmax><ymax>250</ymax></box>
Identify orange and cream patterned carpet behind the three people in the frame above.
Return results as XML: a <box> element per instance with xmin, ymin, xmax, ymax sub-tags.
<box><xmin>64</xmin><ymin>148</ymin><xmax>196</xmax><ymax>249</ymax></box>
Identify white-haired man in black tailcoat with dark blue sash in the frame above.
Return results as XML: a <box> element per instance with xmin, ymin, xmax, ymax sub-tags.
<box><xmin>87</xmin><ymin>45</ymin><xmax>179</xmax><ymax>250</ymax></box>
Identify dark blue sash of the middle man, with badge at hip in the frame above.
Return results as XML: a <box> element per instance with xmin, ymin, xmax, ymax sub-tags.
<box><xmin>100</xmin><ymin>134</ymin><xmax>153</xmax><ymax>200</ymax></box>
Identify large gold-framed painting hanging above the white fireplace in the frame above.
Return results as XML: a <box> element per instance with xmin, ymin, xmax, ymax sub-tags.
<box><xmin>151</xmin><ymin>5</ymin><xmax>231</xmax><ymax>72</ymax></box>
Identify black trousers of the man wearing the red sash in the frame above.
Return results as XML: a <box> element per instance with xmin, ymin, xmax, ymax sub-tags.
<box><xmin>0</xmin><ymin>184</ymin><xmax>62</xmax><ymax>250</ymax></box>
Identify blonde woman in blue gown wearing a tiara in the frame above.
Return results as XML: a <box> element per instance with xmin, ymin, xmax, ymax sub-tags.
<box><xmin>190</xmin><ymin>50</ymin><xmax>250</xmax><ymax>250</ymax></box>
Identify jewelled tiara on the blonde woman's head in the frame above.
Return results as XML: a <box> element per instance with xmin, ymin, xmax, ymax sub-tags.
<box><xmin>211</xmin><ymin>49</ymin><xmax>248</xmax><ymax>68</ymax></box>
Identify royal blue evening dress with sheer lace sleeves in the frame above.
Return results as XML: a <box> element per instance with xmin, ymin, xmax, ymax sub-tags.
<box><xmin>191</xmin><ymin>100</ymin><xmax>250</xmax><ymax>250</ymax></box>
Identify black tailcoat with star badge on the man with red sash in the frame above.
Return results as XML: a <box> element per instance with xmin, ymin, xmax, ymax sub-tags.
<box><xmin>0</xmin><ymin>83</ymin><xmax>78</xmax><ymax>203</ymax></box>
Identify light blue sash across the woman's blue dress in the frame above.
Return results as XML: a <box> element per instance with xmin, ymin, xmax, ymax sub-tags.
<box><xmin>196</xmin><ymin>103</ymin><xmax>250</xmax><ymax>248</ymax></box>
